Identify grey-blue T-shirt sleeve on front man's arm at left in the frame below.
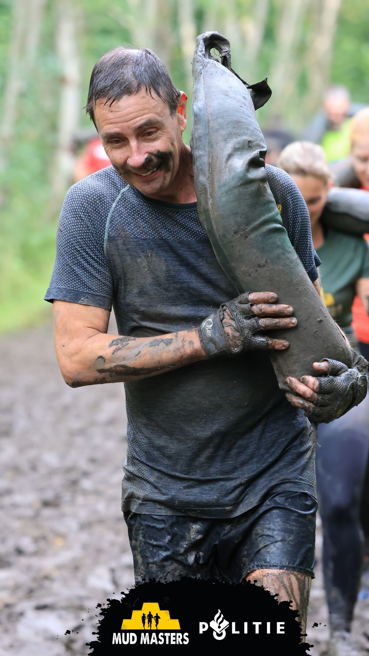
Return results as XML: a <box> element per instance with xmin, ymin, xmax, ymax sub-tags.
<box><xmin>45</xmin><ymin>179</ymin><xmax>113</xmax><ymax>310</ymax></box>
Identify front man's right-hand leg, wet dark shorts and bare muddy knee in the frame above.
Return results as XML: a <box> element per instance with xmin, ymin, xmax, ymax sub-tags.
<box><xmin>217</xmin><ymin>490</ymin><xmax>317</xmax><ymax>633</ymax></box>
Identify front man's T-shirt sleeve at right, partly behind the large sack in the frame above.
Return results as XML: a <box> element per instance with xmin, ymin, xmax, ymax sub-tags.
<box><xmin>266</xmin><ymin>164</ymin><xmax>321</xmax><ymax>282</ymax></box>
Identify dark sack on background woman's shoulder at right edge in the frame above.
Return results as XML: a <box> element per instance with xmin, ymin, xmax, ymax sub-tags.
<box><xmin>320</xmin><ymin>187</ymin><xmax>369</xmax><ymax>235</ymax></box>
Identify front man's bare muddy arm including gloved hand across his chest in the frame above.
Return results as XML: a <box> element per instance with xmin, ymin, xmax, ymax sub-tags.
<box><xmin>54</xmin><ymin>292</ymin><xmax>296</xmax><ymax>387</ymax></box>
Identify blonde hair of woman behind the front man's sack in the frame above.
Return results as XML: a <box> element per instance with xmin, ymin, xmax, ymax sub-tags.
<box><xmin>277</xmin><ymin>141</ymin><xmax>333</xmax><ymax>184</ymax></box>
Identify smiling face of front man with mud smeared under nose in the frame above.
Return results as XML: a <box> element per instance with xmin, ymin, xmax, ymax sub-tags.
<box><xmin>95</xmin><ymin>90</ymin><xmax>187</xmax><ymax>199</ymax></box>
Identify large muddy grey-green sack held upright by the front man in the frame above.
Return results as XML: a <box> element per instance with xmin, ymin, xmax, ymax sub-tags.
<box><xmin>191</xmin><ymin>32</ymin><xmax>351</xmax><ymax>389</ymax></box>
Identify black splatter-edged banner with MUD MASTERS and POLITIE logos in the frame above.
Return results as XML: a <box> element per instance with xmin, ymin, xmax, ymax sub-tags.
<box><xmin>88</xmin><ymin>579</ymin><xmax>311</xmax><ymax>656</ymax></box>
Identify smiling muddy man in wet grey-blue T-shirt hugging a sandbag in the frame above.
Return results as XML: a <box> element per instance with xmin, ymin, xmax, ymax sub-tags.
<box><xmin>46</xmin><ymin>48</ymin><xmax>366</xmax><ymax>640</ymax></box>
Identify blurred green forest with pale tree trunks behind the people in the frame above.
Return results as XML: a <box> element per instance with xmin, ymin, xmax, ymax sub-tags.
<box><xmin>0</xmin><ymin>0</ymin><xmax>369</xmax><ymax>332</ymax></box>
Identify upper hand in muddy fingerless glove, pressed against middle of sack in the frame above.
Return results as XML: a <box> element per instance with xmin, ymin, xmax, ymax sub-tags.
<box><xmin>199</xmin><ymin>292</ymin><xmax>297</xmax><ymax>357</ymax></box>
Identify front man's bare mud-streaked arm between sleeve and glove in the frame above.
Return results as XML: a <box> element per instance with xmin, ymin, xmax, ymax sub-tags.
<box><xmin>54</xmin><ymin>301</ymin><xmax>207</xmax><ymax>387</ymax></box>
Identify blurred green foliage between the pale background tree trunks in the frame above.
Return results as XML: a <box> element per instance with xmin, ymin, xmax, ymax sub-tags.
<box><xmin>0</xmin><ymin>0</ymin><xmax>369</xmax><ymax>331</ymax></box>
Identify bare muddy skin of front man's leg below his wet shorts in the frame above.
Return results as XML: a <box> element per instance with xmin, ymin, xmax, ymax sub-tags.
<box><xmin>246</xmin><ymin>569</ymin><xmax>311</xmax><ymax>633</ymax></box>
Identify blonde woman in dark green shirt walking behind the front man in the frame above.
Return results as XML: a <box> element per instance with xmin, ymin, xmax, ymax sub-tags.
<box><xmin>278</xmin><ymin>141</ymin><xmax>369</xmax><ymax>656</ymax></box>
